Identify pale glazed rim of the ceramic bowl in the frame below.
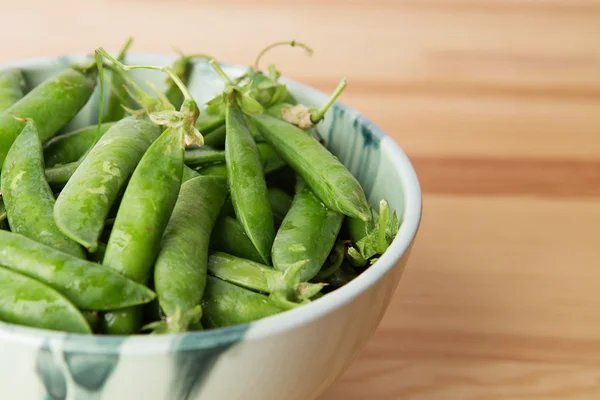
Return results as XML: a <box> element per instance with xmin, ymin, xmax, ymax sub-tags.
<box><xmin>0</xmin><ymin>52</ymin><xmax>422</xmax><ymax>355</ymax></box>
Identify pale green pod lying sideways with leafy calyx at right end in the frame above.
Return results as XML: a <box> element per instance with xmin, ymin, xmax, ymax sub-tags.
<box><xmin>208</xmin><ymin>252</ymin><xmax>323</xmax><ymax>309</ymax></box>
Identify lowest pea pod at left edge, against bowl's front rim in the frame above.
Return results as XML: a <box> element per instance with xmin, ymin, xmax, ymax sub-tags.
<box><xmin>0</xmin><ymin>267</ymin><xmax>92</xmax><ymax>334</ymax></box>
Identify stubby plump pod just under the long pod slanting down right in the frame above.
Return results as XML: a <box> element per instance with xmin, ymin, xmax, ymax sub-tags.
<box><xmin>272</xmin><ymin>179</ymin><xmax>344</xmax><ymax>281</ymax></box>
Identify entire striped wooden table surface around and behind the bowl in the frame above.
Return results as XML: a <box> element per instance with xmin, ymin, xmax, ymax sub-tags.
<box><xmin>0</xmin><ymin>0</ymin><xmax>600</xmax><ymax>400</ymax></box>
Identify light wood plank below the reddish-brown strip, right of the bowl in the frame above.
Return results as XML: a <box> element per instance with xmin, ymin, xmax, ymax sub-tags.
<box><xmin>320</xmin><ymin>196</ymin><xmax>600</xmax><ymax>400</ymax></box>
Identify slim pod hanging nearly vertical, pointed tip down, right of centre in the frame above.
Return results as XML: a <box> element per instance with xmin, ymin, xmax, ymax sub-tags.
<box><xmin>225</xmin><ymin>104</ymin><xmax>275</xmax><ymax>264</ymax></box>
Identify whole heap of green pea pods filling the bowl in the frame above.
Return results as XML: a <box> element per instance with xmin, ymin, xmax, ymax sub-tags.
<box><xmin>0</xmin><ymin>41</ymin><xmax>399</xmax><ymax>335</ymax></box>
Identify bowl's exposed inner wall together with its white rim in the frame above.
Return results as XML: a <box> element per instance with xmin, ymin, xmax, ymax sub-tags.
<box><xmin>0</xmin><ymin>55</ymin><xmax>421</xmax><ymax>351</ymax></box>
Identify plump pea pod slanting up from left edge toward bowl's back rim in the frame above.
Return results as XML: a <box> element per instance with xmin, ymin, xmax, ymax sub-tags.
<box><xmin>0</xmin><ymin>63</ymin><xmax>97</xmax><ymax>164</ymax></box>
